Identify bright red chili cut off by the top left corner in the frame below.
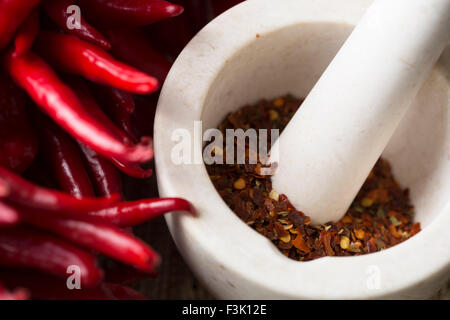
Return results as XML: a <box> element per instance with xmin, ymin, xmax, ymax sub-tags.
<box><xmin>0</xmin><ymin>0</ymin><xmax>39</xmax><ymax>50</ymax></box>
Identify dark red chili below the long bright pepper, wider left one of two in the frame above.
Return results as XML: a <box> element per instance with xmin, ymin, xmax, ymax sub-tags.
<box><xmin>36</xmin><ymin>114</ymin><xmax>95</xmax><ymax>198</ymax></box>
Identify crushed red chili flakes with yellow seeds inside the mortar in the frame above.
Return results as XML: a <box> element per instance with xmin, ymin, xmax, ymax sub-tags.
<box><xmin>207</xmin><ymin>96</ymin><xmax>420</xmax><ymax>261</ymax></box>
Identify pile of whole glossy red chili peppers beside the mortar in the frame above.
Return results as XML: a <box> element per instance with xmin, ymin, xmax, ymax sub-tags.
<box><xmin>0</xmin><ymin>0</ymin><xmax>246</xmax><ymax>300</ymax></box>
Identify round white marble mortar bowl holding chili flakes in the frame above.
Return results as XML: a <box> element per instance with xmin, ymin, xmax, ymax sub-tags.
<box><xmin>154</xmin><ymin>0</ymin><xmax>450</xmax><ymax>299</ymax></box>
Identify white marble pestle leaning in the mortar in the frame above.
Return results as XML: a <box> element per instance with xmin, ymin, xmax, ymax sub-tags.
<box><xmin>270</xmin><ymin>0</ymin><xmax>450</xmax><ymax>223</ymax></box>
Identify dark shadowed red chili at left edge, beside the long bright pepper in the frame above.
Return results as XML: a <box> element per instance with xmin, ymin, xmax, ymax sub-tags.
<box><xmin>0</xmin><ymin>74</ymin><xmax>38</xmax><ymax>173</ymax></box>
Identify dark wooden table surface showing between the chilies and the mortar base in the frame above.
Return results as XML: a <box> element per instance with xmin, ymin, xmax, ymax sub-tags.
<box><xmin>126</xmin><ymin>172</ymin><xmax>450</xmax><ymax>300</ymax></box>
